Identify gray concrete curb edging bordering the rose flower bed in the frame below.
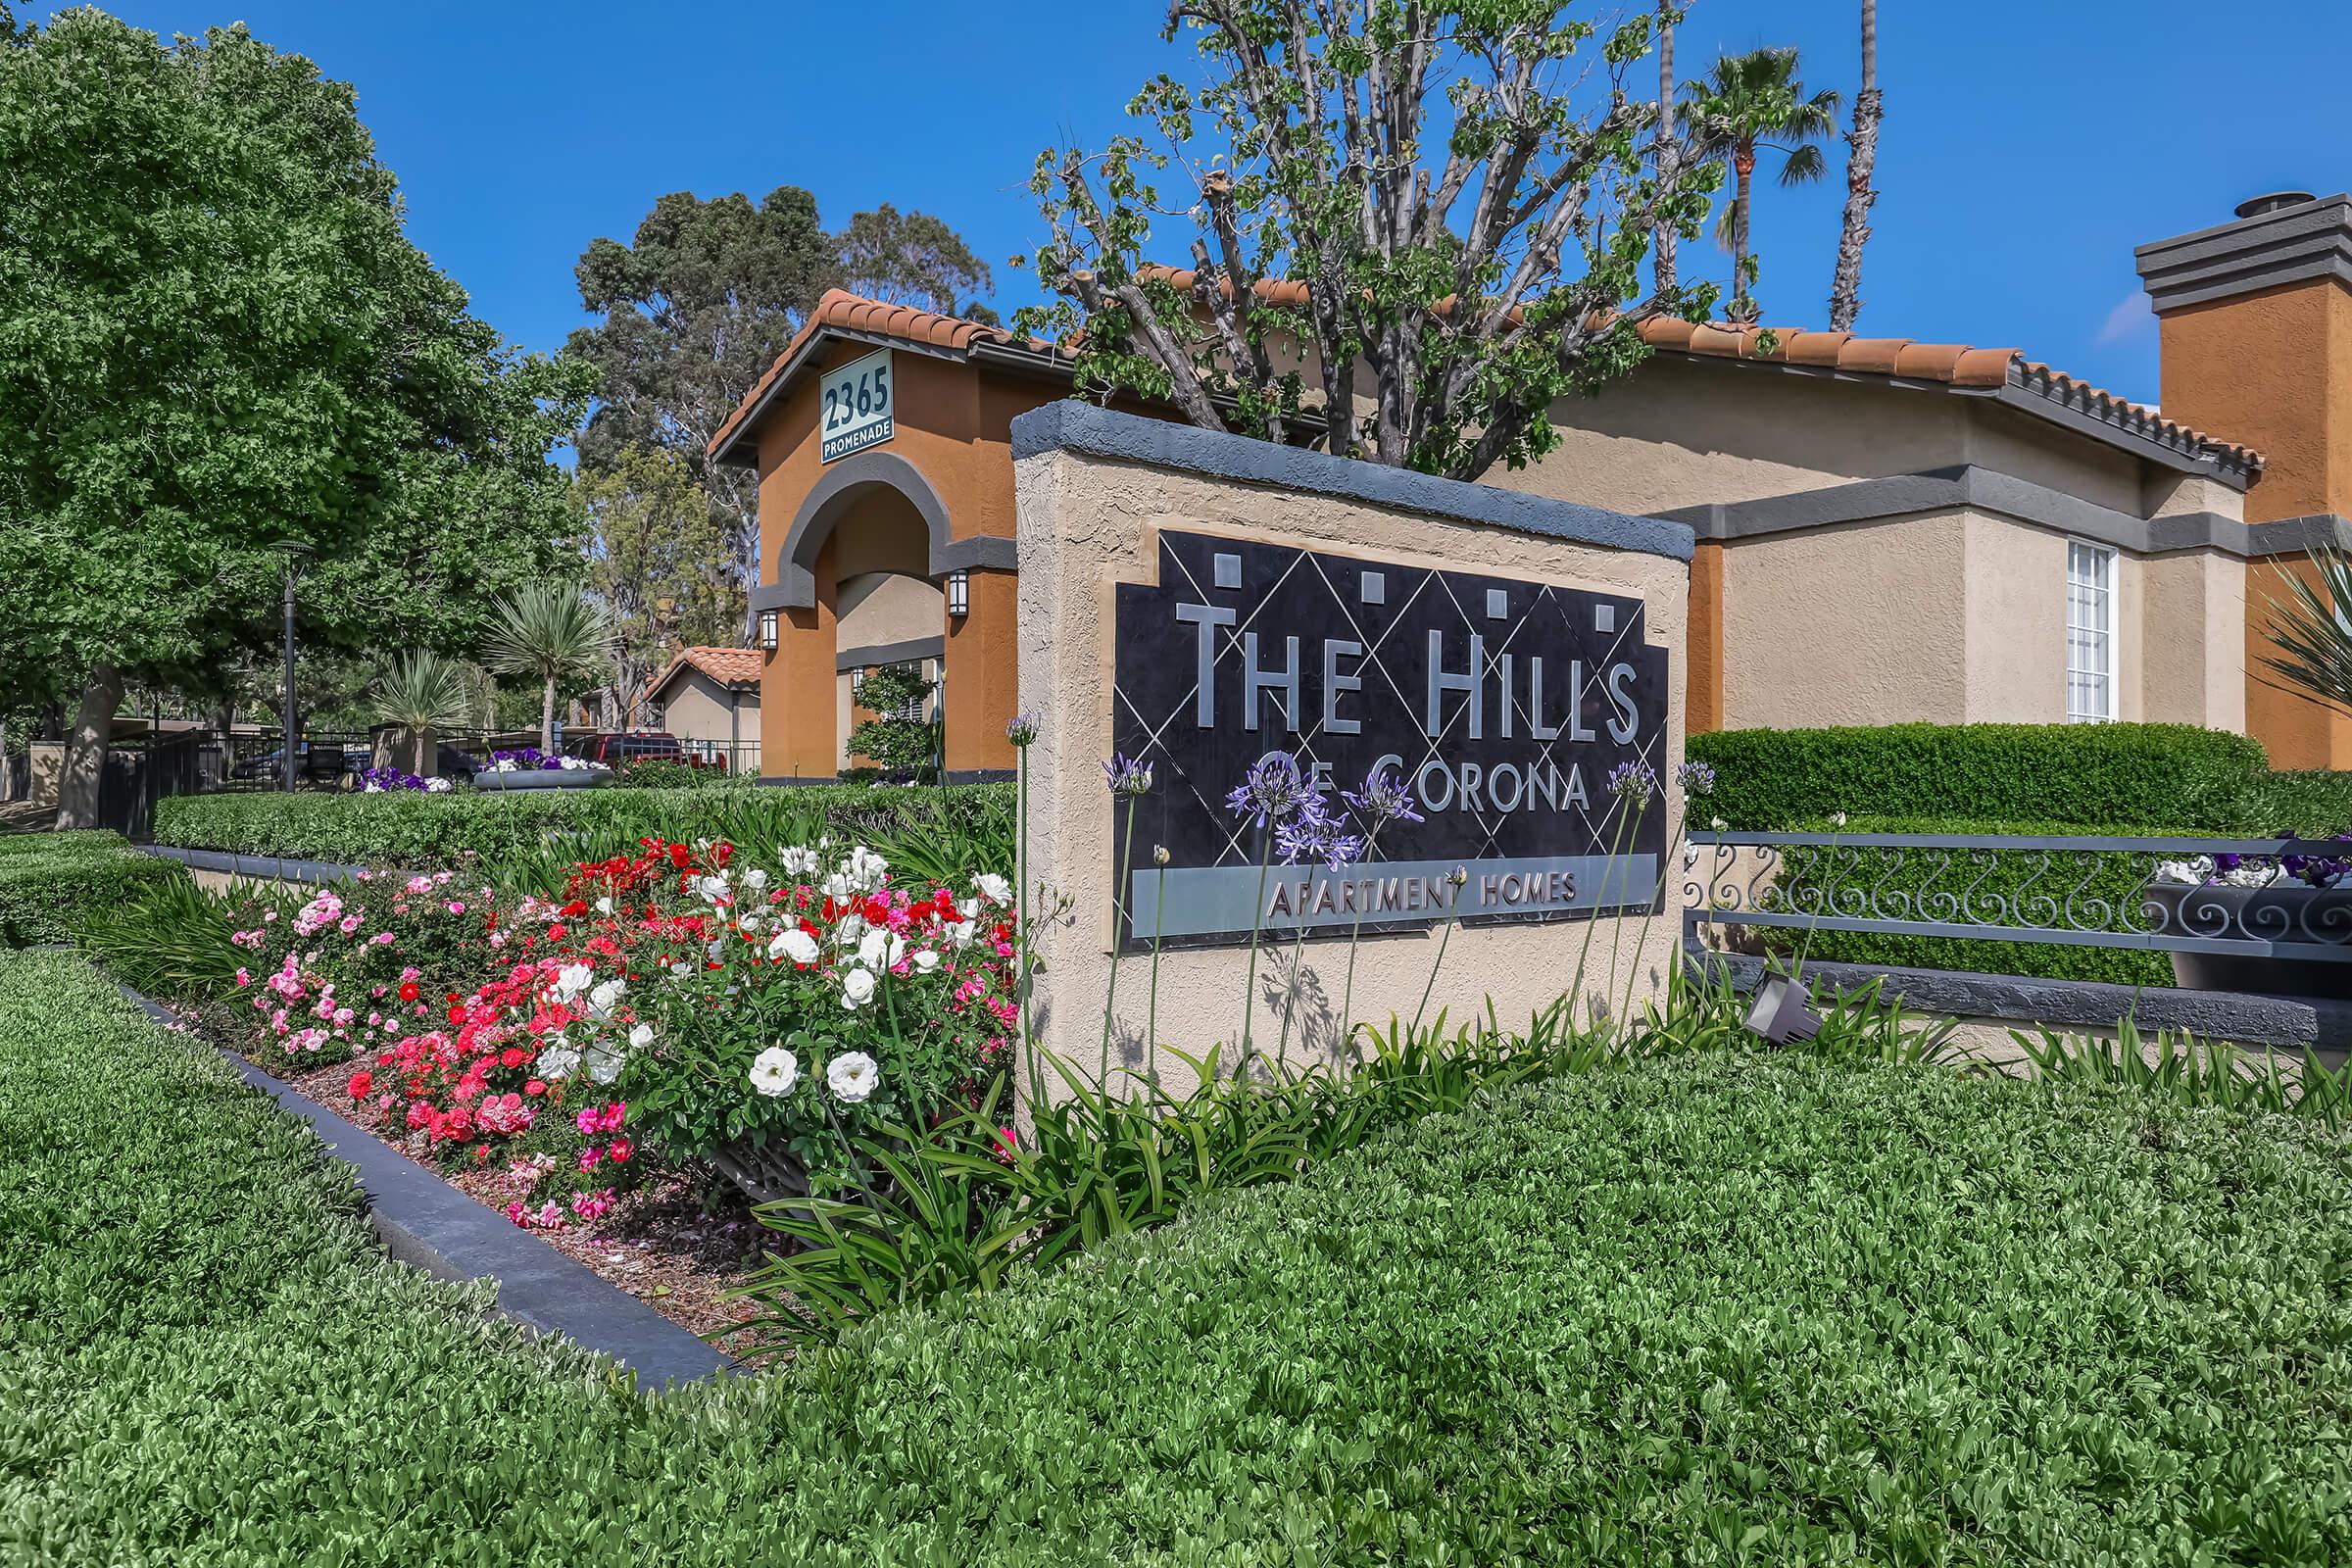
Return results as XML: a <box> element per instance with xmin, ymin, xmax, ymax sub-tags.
<box><xmin>120</xmin><ymin>985</ymin><xmax>736</xmax><ymax>1392</ymax></box>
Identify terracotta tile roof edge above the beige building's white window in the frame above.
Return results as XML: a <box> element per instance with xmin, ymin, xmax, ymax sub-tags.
<box><xmin>1642</xmin><ymin>318</ymin><xmax>2263</xmax><ymax>467</ymax></box>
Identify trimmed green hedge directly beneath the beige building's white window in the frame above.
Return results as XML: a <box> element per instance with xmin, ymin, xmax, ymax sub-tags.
<box><xmin>1689</xmin><ymin>724</ymin><xmax>2277</xmax><ymax>832</ymax></box>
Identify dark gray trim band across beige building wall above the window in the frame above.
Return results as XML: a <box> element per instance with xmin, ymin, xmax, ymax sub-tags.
<box><xmin>1665</xmin><ymin>464</ymin><xmax>2267</xmax><ymax>558</ymax></box>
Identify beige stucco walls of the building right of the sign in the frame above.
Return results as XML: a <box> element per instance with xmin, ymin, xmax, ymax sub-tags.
<box><xmin>1489</xmin><ymin>355</ymin><xmax>2246</xmax><ymax>729</ymax></box>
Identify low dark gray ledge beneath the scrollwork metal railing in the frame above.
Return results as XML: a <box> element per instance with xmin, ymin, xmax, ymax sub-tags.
<box><xmin>1695</xmin><ymin>953</ymin><xmax>2352</xmax><ymax>1049</ymax></box>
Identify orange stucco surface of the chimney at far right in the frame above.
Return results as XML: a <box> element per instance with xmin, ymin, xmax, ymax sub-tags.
<box><xmin>2162</xmin><ymin>277</ymin><xmax>2352</xmax><ymax>768</ymax></box>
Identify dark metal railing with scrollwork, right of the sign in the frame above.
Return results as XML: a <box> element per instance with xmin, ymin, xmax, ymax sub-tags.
<box><xmin>1682</xmin><ymin>832</ymin><xmax>2352</xmax><ymax>961</ymax></box>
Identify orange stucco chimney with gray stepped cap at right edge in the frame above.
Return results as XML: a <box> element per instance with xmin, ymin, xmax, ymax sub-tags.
<box><xmin>2135</xmin><ymin>190</ymin><xmax>2352</xmax><ymax>768</ymax></box>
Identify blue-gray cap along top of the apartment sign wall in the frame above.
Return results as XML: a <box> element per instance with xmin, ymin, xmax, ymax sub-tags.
<box><xmin>1013</xmin><ymin>400</ymin><xmax>1691</xmax><ymax>562</ymax></box>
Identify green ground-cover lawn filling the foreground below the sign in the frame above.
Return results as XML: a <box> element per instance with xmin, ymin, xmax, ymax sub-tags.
<box><xmin>0</xmin><ymin>955</ymin><xmax>2352</xmax><ymax>1568</ymax></box>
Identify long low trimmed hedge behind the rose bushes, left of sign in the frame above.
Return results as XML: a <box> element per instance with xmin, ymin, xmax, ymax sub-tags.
<box><xmin>155</xmin><ymin>785</ymin><xmax>1011</xmax><ymax>870</ymax></box>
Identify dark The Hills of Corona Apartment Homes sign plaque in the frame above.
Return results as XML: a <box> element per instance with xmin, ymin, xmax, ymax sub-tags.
<box><xmin>1110</xmin><ymin>531</ymin><xmax>1668</xmax><ymax>943</ymax></box>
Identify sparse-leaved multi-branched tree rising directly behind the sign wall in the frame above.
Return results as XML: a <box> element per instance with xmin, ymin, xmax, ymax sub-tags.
<box><xmin>1021</xmin><ymin>0</ymin><xmax>1722</xmax><ymax>479</ymax></box>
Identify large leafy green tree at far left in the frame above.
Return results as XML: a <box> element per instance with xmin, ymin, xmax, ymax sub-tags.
<box><xmin>0</xmin><ymin>10</ymin><xmax>593</xmax><ymax>825</ymax></box>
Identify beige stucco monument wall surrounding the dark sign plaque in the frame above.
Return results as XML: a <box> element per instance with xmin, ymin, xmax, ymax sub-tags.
<box><xmin>1016</xmin><ymin>441</ymin><xmax>1687</xmax><ymax>1079</ymax></box>
